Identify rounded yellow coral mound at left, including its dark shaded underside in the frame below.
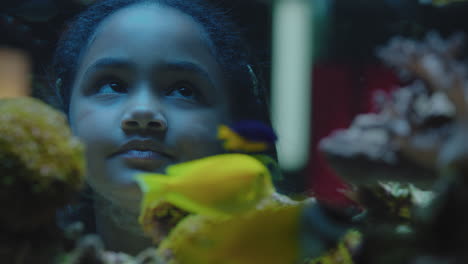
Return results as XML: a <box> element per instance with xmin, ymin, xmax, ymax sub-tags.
<box><xmin>0</xmin><ymin>97</ymin><xmax>85</xmax><ymax>230</ymax></box>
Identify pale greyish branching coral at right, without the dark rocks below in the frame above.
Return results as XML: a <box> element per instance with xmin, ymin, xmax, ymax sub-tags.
<box><xmin>320</xmin><ymin>33</ymin><xmax>467</xmax><ymax>187</ymax></box>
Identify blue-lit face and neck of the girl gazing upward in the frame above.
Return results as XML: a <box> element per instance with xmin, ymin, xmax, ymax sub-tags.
<box><xmin>70</xmin><ymin>5</ymin><xmax>229</xmax><ymax>211</ymax></box>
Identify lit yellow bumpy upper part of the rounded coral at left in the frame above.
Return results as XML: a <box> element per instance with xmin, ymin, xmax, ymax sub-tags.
<box><xmin>0</xmin><ymin>97</ymin><xmax>84</xmax><ymax>190</ymax></box>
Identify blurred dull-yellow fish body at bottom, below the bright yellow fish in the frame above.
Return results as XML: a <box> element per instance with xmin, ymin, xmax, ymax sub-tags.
<box><xmin>158</xmin><ymin>204</ymin><xmax>304</xmax><ymax>264</ymax></box>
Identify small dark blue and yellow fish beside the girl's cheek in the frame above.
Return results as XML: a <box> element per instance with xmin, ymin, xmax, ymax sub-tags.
<box><xmin>218</xmin><ymin>120</ymin><xmax>277</xmax><ymax>153</ymax></box>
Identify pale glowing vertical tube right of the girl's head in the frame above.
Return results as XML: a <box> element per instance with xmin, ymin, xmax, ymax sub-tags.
<box><xmin>271</xmin><ymin>0</ymin><xmax>313</xmax><ymax>171</ymax></box>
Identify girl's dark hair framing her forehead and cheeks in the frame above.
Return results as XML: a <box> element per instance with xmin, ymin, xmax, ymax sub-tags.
<box><xmin>48</xmin><ymin>0</ymin><xmax>270</xmax><ymax>124</ymax></box>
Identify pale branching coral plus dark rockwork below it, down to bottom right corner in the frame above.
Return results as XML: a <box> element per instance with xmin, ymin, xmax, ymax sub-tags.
<box><xmin>321</xmin><ymin>33</ymin><xmax>468</xmax><ymax>264</ymax></box>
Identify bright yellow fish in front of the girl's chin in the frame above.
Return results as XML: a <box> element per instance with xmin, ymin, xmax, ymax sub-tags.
<box><xmin>136</xmin><ymin>153</ymin><xmax>275</xmax><ymax>222</ymax></box>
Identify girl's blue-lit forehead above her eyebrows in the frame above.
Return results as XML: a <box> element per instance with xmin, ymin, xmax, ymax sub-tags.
<box><xmin>81</xmin><ymin>5</ymin><xmax>219</xmax><ymax>74</ymax></box>
